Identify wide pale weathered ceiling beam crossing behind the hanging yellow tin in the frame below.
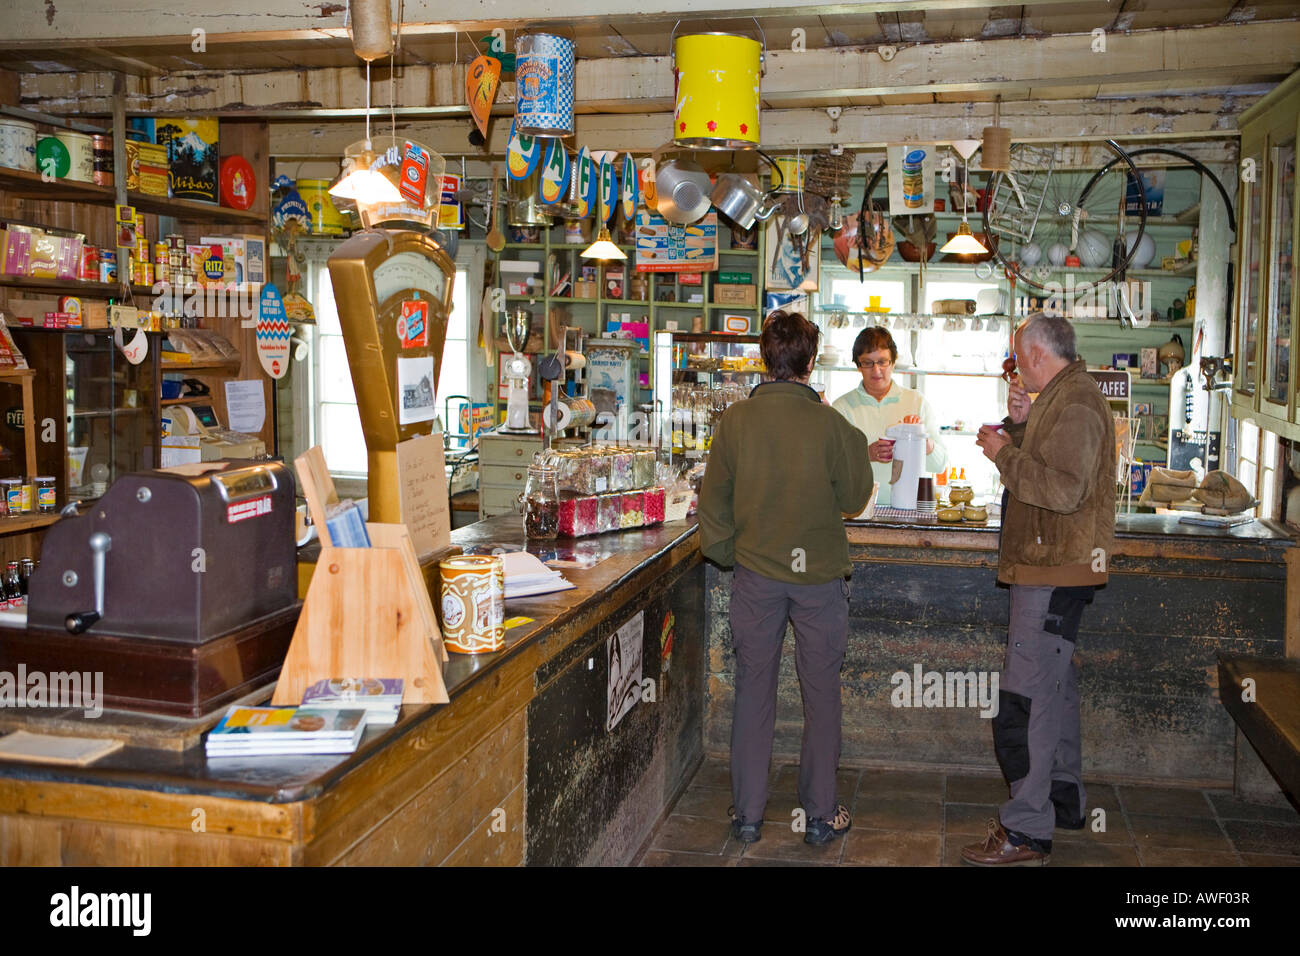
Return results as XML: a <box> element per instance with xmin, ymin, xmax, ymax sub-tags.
<box><xmin>22</xmin><ymin>21</ymin><xmax>1300</xmax><ymax>116</ymax></box>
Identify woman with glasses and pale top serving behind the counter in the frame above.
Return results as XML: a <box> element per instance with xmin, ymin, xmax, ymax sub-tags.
<box><xmin>832</xmin><ymin>325</ymin><xmax>948</xmax><ymax>505</ymax></box>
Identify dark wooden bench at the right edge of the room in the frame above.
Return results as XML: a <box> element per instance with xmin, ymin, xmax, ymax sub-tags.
<box><xmin>1219</xmin><ymin>654</ymin><xmax>1300</xmax><ymax>803</ymax></box>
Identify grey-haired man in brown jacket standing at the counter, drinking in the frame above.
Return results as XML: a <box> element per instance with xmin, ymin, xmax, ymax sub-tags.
<box><xmin>962</xmin><ymin>312</ymin><xmax>1115</xmax><ymax>866</ymax></box>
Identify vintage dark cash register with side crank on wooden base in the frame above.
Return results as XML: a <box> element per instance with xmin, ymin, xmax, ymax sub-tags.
<box><xmin>0</xmin><ymin>462</ymin><xmax>300</xmax><ymax>717</ymax></box>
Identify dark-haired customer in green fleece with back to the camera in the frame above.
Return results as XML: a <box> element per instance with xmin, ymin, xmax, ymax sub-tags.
<box><xmin>698</xmin><ymin>312</ymin><xmax>872</xmax><ymax>844</ymax></box>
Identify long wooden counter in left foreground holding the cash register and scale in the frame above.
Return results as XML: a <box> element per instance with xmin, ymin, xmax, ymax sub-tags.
<box><xmin>0</xmin><ymin>518</ymin><xmax>705</xmax><ymax>865</ymax></box>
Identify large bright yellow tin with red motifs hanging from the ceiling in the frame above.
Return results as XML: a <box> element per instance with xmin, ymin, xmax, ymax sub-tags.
<box><xmin>672</xmin><ymin>34</ymin><xmax>763</xmax><ymax>150</ymax></box>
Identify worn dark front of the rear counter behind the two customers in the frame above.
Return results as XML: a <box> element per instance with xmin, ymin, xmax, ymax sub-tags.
<box><xmin>705</xmin><ymin>515</ymin><xmax>1300</xmax><ymax>786</ymax></box>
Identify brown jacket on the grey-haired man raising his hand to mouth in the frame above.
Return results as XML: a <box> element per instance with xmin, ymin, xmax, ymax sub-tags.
<box><xmin>996</xmin><ymin>360</ymin><xmax>1115</xmax><ymax>587</ymax></box>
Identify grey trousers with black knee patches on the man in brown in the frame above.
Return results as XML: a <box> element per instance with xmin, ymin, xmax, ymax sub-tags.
<box><xmin>993</xmin><ymin>584</ymin><xmax>1093</xmax><ymax>840</ymax></box>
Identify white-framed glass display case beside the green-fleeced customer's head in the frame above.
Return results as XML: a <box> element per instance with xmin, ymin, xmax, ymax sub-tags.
<box><xmin>653</xmin><ymin>332</ymin><xmax>766</xmax><ymax>462</ymax></box>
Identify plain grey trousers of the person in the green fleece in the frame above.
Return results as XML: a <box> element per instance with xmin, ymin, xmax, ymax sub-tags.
<box><xmin>731</xmin><ymin>564</ymin><xmax>849</xmax><ymax>823</ymax></box>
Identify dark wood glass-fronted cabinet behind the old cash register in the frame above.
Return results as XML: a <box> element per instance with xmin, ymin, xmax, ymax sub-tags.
<box><xmin>60</xmin><ymin>329</ymin><xmax>157</xmax><ymax>503</ymax></box>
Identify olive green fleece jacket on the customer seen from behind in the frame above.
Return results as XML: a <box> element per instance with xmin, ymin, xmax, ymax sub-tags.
<box><xmin>698</xmin><ymin>381</ymin><xmax>872</xmax><ymax>584</ymax></box>
